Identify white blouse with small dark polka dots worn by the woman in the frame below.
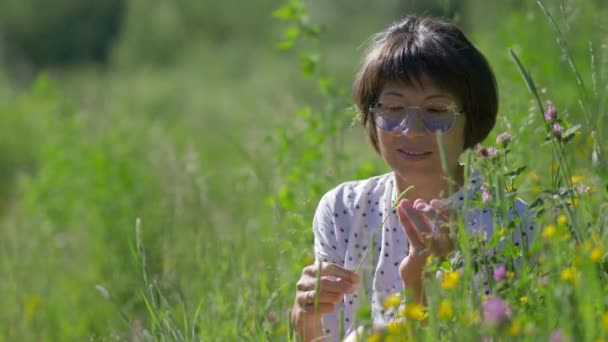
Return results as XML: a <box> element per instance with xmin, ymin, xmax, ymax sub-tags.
<box><xmin>313</xmin><ymin>172</ymin><xmax>532</xmax><ymax>341</ymax></box>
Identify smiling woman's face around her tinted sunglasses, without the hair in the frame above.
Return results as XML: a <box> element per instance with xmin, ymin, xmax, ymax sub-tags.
<box><xmin>373</xmin><ymin>75</ymin><xmax>465</xmax><ymax>190</ymax></box>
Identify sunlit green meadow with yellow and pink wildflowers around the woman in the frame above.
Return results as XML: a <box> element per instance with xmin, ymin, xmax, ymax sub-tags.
<box><xmin>0</xmin><ymin>0</ymin><xmax>608</xmax><ymax>342</ymax></box>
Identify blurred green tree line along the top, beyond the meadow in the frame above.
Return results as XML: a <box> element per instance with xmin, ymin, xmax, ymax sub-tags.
<box><xmin>0</xmin><ymin>0</ymin><xmax>606</xmax><ymax>67</ymax></box>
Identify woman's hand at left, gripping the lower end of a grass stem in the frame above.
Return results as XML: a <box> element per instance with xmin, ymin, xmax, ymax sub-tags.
<box><xmin>291</xmin><ymin>262</ymin><xmax>359</xmax><ymax>341</ymax></box>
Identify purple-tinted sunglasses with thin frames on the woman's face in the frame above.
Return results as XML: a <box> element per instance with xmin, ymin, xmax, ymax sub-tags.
<box><xmin>370</xmin><ymin>102</ymin><xmax>462</xmax><ymax>133</ymax></box>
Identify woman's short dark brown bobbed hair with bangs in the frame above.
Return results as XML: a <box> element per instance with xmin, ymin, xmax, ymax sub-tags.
<box><xmin>353</xmin><ymin>16</ymin><xmax>498</xmax><ymax>152</ymax></box>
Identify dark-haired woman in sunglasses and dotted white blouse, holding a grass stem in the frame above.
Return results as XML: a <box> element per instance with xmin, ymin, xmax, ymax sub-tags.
<box><xmin>292</xmin><ymin>16</ymin><xmax>526</xmax><ymax>341</ymax></box>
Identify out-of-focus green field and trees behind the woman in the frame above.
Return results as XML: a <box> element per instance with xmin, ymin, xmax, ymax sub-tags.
<box><xmin>0</xmin><ymin>0</ymin><xmax>608</xmax><ymax>342</ymax></box>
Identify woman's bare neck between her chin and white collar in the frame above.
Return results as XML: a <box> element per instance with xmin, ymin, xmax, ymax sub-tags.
<box><xmin>395</xmin><ymin>165</ymin><xmax>464</xmax><ymax>203</ymax></box>
